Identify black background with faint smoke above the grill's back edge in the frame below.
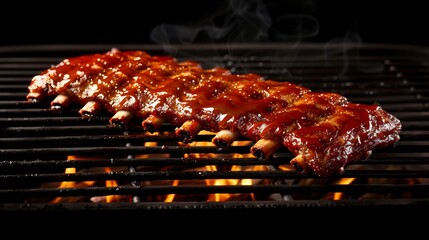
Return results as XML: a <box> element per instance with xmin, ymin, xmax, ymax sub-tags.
<box><xmin>0</xmin><ymin>0</ymin><xmax>429</xmax><ymax>45</ymax></box>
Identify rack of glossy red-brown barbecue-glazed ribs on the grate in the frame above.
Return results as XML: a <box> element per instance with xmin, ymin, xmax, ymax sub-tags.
<box><xmin>27</xmin><ymin>49</ymin><xmax>401</xmax><ymax>176</ymax></box>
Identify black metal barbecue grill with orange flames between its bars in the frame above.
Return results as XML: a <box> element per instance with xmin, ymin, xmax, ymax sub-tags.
<box><xmin>0</xmin><ymin>44</ymin><xmax>429</xmax><ymax>219</ymax></box>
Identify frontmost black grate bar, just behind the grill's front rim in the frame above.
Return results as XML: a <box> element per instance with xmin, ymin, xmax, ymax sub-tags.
<box><xmin>0</xmin><ymin>184</ymin><xmax>429</xmax><ymax>198</ymax></box>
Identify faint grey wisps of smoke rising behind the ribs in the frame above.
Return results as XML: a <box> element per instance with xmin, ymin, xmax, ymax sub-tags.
<box><xmin>150</xmin><ymin>0</ymin><xmax>319</xmax><ymax>44</ymax></box>
